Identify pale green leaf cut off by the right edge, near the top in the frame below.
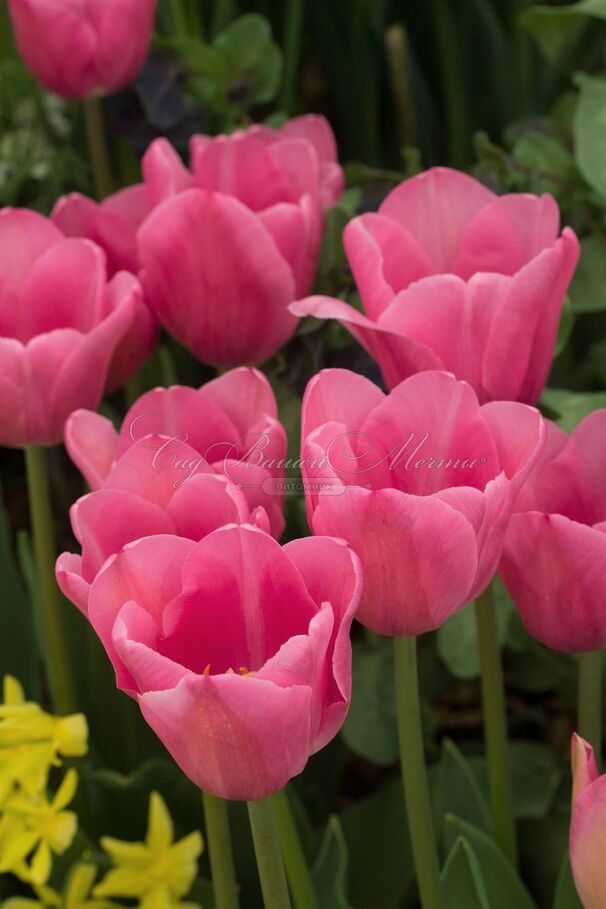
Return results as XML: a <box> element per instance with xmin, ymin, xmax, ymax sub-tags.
<box><xmin>574</xmin><ymin>74</ymin><xmax>606</xmax><ymax>197</ymax></box>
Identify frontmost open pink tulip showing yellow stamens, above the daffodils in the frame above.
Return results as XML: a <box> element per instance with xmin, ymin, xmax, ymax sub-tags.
<box><xmin>78</xmin><ymin>525</ymin><xmax>360</xmax><ymax>799</ymax></box>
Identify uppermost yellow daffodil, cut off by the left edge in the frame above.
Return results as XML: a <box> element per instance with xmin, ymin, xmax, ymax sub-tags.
<box><xmin>0</xmin><ymin>675</ymin><xmax>88</xmax><ymax>805</ymax></box>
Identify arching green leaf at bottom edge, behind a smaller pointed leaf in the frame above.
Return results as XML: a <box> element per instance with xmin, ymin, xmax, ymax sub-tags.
<box><xmin>445</xmin><ymin>815</ymin><xmax>537</xmax><ymax>909</ymax></box>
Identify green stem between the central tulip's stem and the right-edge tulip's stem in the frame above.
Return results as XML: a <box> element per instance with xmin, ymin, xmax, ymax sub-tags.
<box><xmin>476</xmin><ymin>587</ymin><xmax>517</xmax><ymax>865</ymax></box>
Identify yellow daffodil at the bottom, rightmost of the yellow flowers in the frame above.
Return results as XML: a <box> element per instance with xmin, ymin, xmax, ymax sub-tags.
<box><xmin>93</xmin><ymin>792</ymin><xmax>203</xmax><ymax>909</ymax></box>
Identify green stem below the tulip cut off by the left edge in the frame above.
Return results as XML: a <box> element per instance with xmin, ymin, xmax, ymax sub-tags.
<box><xmin>25</xmin><ymin>445</ymin><xmax>76</xmax><ymax>715</ymax></box>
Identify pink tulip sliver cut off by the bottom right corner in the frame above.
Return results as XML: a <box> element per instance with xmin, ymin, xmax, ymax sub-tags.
<box><xmin>570</xmin><ymin>734</ymin><xmax>606</xmax><ymax>909</ymax></box>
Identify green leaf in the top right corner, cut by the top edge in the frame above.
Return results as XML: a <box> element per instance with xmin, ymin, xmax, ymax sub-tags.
<box><xmin>519</xmin><ymin>0</ymin><xmax>606</xmax><ymax>63</ymax></box>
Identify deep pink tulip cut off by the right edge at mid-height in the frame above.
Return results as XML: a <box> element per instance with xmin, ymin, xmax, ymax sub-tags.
<box><xmin>500</xmin><ymin>410</ymin><xmax>606</xmax><ymax>652</ymax></box>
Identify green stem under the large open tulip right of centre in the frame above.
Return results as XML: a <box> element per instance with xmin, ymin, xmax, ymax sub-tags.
<box><xmin>394</xmin><ymin>637</ymin><xmax>442</xmax><ymax>909</ymax></box>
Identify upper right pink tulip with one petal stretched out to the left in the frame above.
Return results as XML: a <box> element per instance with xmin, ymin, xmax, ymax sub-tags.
<box><xmin>291</xmin><ymin>167</ymin><xmax>579</xmax><ymax>404</ymax></box>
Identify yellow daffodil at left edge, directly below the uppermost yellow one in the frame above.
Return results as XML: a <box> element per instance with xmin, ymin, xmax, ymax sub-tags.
<box><xmin>0</xmin><ymin>769</ymin><xmax>78</xmax><ymax>886</ymax></box>
